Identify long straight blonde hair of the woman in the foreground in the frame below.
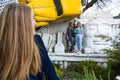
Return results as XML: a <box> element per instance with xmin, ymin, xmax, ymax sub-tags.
<box><xmin>0</xmin><ymin>3</ymin><xmax>41</xmax><ymax>80</ymax></box>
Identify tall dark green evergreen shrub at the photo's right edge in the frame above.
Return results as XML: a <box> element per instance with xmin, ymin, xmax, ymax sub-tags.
<box><xmin>103</xmin><ymin>33</ymin><xmax>120</xmax><ymax>80</ymax></box>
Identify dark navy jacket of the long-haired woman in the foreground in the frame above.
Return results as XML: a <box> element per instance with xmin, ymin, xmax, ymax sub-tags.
<box><xmin>30</xmin><ymin>35</ymin><xmax>59</xmax><ymax>80</ymax></box>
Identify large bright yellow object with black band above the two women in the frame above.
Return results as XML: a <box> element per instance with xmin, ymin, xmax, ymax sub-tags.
<box><xmin>19</xmin><ymin>0</ymin><xmax>82</xmax><ymax>27</ymax></box>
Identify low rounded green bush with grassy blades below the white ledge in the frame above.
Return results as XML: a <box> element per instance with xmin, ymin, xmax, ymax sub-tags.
<box><xmin>64</xmin><ymin>61</ymin><xmax>110</xmax><ymax>80</ymax></box>
